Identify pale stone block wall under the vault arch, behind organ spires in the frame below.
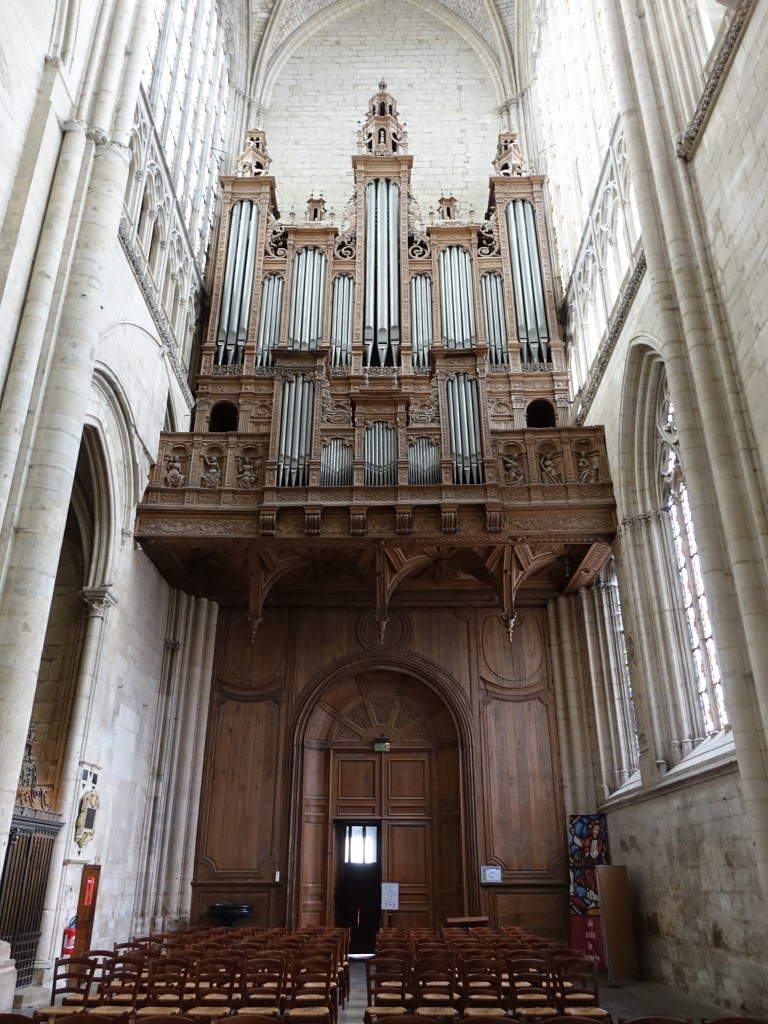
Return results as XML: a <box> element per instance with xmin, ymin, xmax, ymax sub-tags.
<box><xmin>264</xmin><ymin>0</ymin><xmax>502</xmax><ymax>219</ymax></box>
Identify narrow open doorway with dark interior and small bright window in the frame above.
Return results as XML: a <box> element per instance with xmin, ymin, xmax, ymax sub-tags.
<box><xmin>335</xmin><ymin>821</ymin><xmax>381</xmax><ymax>953</ymax></box>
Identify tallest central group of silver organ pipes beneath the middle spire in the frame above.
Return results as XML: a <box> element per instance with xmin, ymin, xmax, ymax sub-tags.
<box><xmin>364</xmin><ymin>178</ymin><xmax>400</xmax><ymax>367</ymax></box>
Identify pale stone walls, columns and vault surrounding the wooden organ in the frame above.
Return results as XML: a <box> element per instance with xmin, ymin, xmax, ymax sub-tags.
<box><xmin>0</xmin><ymin>0</ymin><xmax>768</xmax><ymax>1016</ymax></box>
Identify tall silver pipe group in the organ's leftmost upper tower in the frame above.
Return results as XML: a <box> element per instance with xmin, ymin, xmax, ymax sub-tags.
<box><xmin>216</xmin><ymin>200</ymin><xmax>259</xmax><ymax>366</ymax></box>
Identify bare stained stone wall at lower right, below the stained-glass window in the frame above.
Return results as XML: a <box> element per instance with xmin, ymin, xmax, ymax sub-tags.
<box><xmin>608</xmin><ymin>766</ymin><xmax>768</xmax><ymax>1016</ymax></box>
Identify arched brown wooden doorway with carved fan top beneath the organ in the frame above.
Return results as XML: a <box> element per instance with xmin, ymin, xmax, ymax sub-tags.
<box><xmin>295</xmin><ymin>668</ymin><xmax>465</xmax><ymax>927</ymax></box>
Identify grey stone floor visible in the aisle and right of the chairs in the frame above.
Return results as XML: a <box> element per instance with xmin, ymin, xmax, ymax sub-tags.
<box><xmin>339</xmin><ymin>959</ymin><xmax>727</xmax><ymax>1024</ymax></box>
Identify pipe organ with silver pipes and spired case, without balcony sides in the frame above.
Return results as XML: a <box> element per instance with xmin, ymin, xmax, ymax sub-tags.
<box><xmin>196</xmin><ymin>83</ymin><xmax>567</xmax><ymax>501</ymax></box>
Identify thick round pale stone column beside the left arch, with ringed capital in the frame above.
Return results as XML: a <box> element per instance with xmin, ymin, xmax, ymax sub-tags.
<box><xmin>0</xmin><ymin>0</ymin><xmax>152</xmax><ymax>857</ymax></box>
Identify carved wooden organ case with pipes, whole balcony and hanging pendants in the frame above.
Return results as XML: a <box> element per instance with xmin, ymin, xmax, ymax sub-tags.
<box><xmin>137</xmin><ymin>82</ymin><xmax>615</xmax><ymax>630</ymax></box>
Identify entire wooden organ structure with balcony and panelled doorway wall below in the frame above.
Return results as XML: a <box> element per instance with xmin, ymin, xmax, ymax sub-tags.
<box><xmin>136</xmin><ymin>82</ymin><xmax>616</xmax><ymax>935</ymax></box>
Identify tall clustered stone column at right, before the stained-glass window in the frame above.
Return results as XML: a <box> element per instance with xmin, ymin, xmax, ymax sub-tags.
<box><xmin>602</xmin><ymin>0</ymin><xmax>768</xmax><ymax>893</ymax></box>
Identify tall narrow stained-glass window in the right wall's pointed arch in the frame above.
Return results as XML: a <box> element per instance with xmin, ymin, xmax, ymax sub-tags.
<box><xmin>658</xmin><ymin>391</ymin><xmax>728</xmax><ymax>735</ymax></box>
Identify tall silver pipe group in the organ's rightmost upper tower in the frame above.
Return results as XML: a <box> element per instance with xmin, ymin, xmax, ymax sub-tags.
<box><xmin>507</xmin><ymin>199</ymin><xmax>549</xmax><ymax>362</ymax></box>
